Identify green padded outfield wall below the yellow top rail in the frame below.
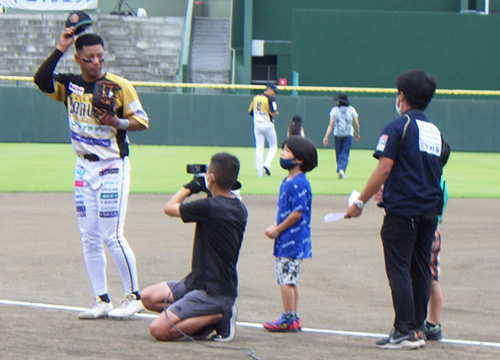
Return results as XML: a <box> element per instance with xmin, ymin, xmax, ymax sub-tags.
<box><xmin>0</xmin><ymin>86</ymin><xmax>500</xmax><ymax>152</ymax></box>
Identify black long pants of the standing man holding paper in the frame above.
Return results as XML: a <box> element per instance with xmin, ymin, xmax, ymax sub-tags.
<box><xmin>380</xmin><ymin>213</ymin><xmax>437</xmax><ymax>333</ymax></box>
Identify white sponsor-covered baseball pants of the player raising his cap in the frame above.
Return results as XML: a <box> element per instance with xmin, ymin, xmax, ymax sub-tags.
<box><xmin>74</xmin><ymin>157</ymin><xmax>139</xmax><ymax>296</ymax></box>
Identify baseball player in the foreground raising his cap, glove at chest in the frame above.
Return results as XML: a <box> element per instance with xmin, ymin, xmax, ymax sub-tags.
<box><xmin>34</xmin><ymin>19</ymin><xmax>149</xmax><ymax>319</ymax></box>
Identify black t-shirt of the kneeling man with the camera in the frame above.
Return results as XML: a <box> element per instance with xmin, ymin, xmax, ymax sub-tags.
<box><xmin>180</xmin><ymin>196</ymin><xmax>248</xmax><ymax>298</ymax></box>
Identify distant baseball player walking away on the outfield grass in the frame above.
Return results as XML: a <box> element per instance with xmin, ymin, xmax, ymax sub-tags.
<box><xmin>248</xmin><ymin>83</ymin><xmax>279</xmax><ymax>177</ymax></box>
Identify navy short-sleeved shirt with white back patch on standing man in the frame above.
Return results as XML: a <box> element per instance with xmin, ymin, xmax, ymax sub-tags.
<box><xmin>373</xmin><ymin>110</ymin><xmax>442</xmax><ymax>216</ymax></box>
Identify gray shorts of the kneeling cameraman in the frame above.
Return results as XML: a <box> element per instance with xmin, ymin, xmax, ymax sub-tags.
<box><xmin>167</xmin><ymin>281</ymin><xmax>235</xmax><ymax>320</ymax></box>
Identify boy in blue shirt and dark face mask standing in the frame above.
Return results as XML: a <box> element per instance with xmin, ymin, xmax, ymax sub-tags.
<box><xmin>262</xmin><ymin>136</ymin><xmax>318</xmax><ymax>332</ymax></box>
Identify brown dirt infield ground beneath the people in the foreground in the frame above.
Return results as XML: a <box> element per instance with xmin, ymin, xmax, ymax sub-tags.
<box><xmin>0</xmin><ymin>193</ymin><xmax>500</xmax><ymax>360</ymax></box>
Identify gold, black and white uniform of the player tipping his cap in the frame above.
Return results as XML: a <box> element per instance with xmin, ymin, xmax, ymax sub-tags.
<box><xmin>35</xmin><ymin>49</ymin><xmax>149</xmax><ymax>318</ymax></box>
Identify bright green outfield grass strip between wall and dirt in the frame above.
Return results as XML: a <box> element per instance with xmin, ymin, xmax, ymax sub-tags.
<box><xmin>0</xmin><ymin>143</ymin><xmax>500</xmax><ymax>198</ymax></box>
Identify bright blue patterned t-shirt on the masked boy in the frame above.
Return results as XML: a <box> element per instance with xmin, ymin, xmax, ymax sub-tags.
<box><xmin>274</xmin><ymin>174</ymin><xmax>312</xmax><ymax>259</ymax></box>
